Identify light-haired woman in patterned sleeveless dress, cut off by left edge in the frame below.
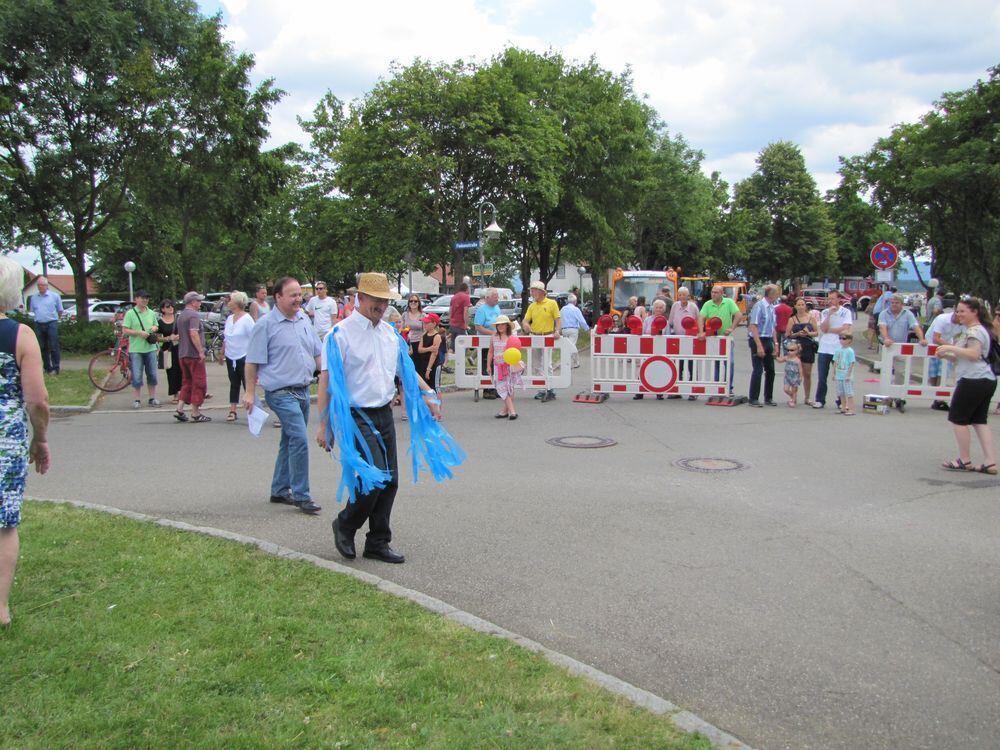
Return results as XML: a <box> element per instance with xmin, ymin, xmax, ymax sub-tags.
<box><xmin>0</xmin><ymin>257</ymin><xmax>49</xmax><ymax>626</ymax></box>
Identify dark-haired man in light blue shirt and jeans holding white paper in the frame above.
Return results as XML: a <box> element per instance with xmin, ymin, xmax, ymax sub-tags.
<box><xmin>244</xmin><ymin>277</ymin><xmax>322</xmax><ymax>513</ymax></box>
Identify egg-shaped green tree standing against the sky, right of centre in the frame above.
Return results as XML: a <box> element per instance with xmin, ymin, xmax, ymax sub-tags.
<box><xmin>733</xmin><ymin>141</ymin><xmax>837</xmax><ymax>280</ymax></box>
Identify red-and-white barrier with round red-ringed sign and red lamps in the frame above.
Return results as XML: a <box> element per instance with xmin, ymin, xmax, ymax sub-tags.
<box><xmin>590</xmin><ymin>334</ymin><xmax>733</xmax><ymax>396</ymax></box>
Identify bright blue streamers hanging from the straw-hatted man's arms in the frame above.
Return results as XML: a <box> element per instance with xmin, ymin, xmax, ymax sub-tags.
<box><xmin>326</xmin><ymin>327</ymin><xmax>466</xmax><ymax>503</ymax></box>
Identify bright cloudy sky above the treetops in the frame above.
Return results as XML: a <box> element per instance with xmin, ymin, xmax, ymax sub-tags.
<box><xmin>199</xmin><ymin>0</ymin><xmax>1000</xmax><ymax>190</ymax></box>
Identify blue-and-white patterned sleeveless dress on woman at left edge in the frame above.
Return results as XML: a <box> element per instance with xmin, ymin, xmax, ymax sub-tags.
<box><xmin>0</xmin><ymin>318</ymin><xmax>28</xmax><ymax>529</ymax></box>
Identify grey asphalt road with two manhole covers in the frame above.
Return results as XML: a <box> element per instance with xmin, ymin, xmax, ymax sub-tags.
<box><xmin>27</xmin><ymin>348</ymin><xmax>1000</xmax><ymax>748</ymax></box>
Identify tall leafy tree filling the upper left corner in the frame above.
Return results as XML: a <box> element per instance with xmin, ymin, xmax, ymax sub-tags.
<box><xmin>0</xmin><ymin>0</ymin><xmax>280</xmax><ymax>317</ymax></box>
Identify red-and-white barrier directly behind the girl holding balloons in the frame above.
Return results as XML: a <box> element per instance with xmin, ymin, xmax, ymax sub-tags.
<box><xmin>455</xmin><ymin>333</ymin><xmax>574</xmax><ymax>400</ymax></box>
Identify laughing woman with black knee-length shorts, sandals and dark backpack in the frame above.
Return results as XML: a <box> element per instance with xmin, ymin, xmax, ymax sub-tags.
<box><xmin>937</xmin><ymin>299</ymin><xmax>997</xmax><ymax>474</ymax></box>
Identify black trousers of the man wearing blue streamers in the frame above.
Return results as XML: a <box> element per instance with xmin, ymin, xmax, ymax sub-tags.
<box><xmin>337</xmin><ymin>404</ymin><xmax>399</xmax><ymax>548</ymax></box>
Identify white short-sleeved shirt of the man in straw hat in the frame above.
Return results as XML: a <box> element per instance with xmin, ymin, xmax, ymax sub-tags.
<box><xmin>320</xmin><ymin>310</ymin><xmax>399</xmax><ymax>409</ymax></box>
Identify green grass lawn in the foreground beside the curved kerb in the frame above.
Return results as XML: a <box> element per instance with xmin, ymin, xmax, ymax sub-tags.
<box><xmin>0</xmin><ymin>502</ymin><xmax>710</xmax><ymax>750</ymax></box>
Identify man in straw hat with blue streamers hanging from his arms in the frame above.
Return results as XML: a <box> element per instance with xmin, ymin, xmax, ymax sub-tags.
<box><xmin>316</xmin><ymin>273</ymin><xmax>464</xmax><ymax>563</ymax></box>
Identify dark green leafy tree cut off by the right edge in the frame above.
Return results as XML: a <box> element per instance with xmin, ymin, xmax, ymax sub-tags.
<box><xmin>858</xmin><ymin>66</ymin><xmax>1000</xmax><ymax>301</ymax></box>
